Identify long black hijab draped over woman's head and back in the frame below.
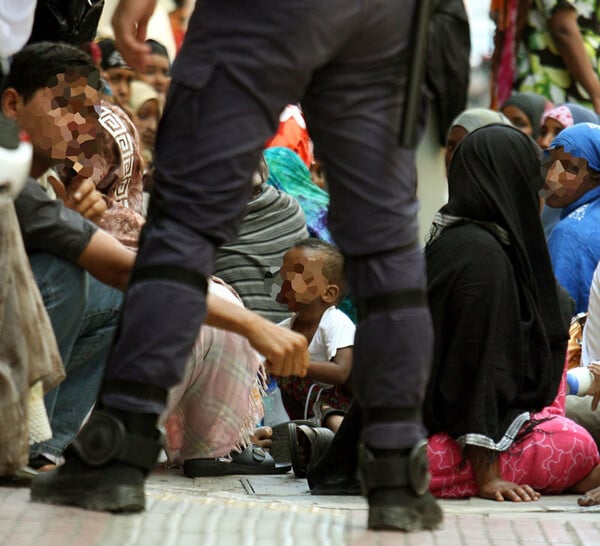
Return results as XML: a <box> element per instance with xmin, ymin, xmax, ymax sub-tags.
<box><xmin>424</xmin><ymin>125</ymin><xmax>567</xmax><ymax>442</ymax></box>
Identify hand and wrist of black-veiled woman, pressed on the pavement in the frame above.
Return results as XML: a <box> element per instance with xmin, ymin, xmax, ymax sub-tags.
<box><xmin>466</xmin><ymin>446</ymin><xmax>541</xmax><ymax>502</ymax></box>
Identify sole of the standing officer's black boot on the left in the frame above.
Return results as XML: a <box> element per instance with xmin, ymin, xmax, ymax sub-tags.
<box><xmin>31</xmin><ymin>485</ymin><xmax>146</xmax><ymax>513</ymax></box>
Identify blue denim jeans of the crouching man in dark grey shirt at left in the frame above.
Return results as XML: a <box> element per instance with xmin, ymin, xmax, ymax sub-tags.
<box><xmin>29</xmin><ymin>253</ymin><xmax>123</xmax><ymax>457</ymax></box>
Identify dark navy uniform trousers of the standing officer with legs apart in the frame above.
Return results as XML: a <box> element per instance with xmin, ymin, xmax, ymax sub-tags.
<box><xmin>101</xmin><ymin>0</ymin><xmax>433</xmax><ymax>448</ymax></box>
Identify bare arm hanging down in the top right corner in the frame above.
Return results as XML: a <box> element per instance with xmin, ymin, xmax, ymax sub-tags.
<box><xmin>548</xmin><ymin>6</ymin><xmax>600</xmax><ymax>113</ymax></box>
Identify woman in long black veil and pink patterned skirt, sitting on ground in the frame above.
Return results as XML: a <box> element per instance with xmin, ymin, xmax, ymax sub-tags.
<box><xmin>424</xmin><ymin>125</ymin><xmax>598</xmax><ymax>500</ymax></box>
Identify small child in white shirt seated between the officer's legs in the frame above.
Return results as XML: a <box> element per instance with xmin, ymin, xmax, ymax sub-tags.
<box><xmin>277</xmin><ymin>238</ymin><xmax>356</xmax><ymax>428</ymax></box>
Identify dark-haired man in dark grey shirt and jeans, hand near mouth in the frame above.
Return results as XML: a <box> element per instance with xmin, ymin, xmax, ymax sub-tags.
<box><xmin>2</xmin><ymin>43</ymin><xmax>135</xmax><ymax>466</ymax></box>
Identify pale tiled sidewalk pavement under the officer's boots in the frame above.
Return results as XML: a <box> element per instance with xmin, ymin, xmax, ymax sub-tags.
<box><xmin>0</xmin><ymin>464</ymin><xmax>600</xmax><ymax>546</ymax></box>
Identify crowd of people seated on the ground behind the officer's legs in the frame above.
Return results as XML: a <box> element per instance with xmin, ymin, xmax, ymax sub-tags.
<box><xmin>8</xmin><ymin>7</ymin><xmax>600</xmax><ymax>516</ymax></box>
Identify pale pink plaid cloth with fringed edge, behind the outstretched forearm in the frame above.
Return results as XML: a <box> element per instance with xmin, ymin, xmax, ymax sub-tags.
<box><xmin>164</xmin><ymin>277</ymin><xmax>264</xmax><ymax>464</ymax></box>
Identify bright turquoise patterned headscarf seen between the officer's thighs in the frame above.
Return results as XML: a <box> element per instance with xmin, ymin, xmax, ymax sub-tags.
<box><xmin>264</xmin><ymin>147</ymin><xmax>333</xmax><ymax>244</ymax></box>
